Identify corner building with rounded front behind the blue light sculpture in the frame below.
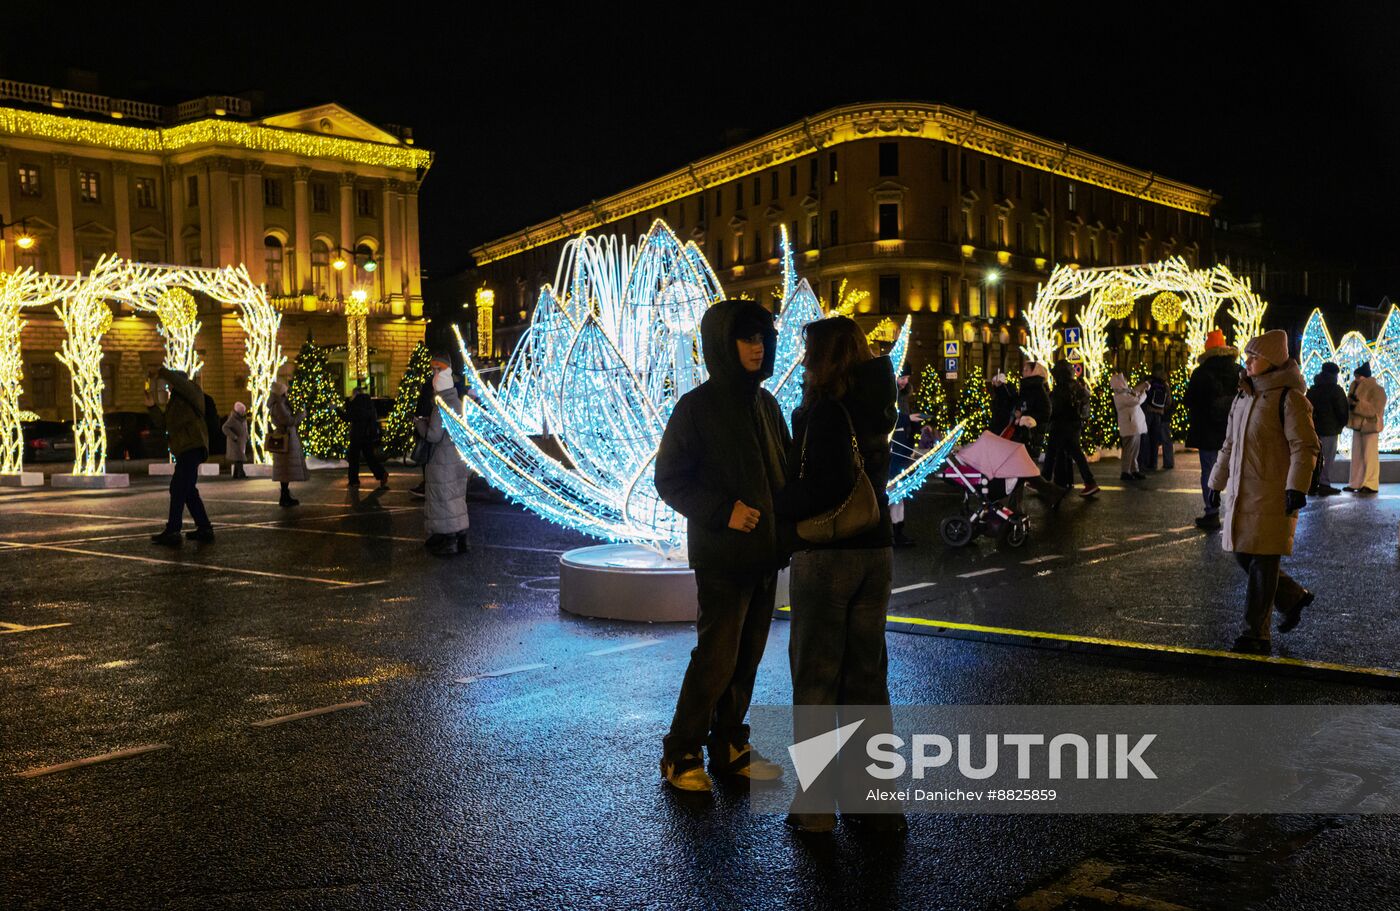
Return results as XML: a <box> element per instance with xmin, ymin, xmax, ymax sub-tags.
<box><xmin>473</xmin><ymin>104</ymin><xmax>1218</xmax><ymax>371</ymax></box>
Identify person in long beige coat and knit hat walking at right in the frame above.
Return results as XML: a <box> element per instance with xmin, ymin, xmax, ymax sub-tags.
<box><xmin>1210</xmin><ymin>329</ymin><xmax>1320</xmax><ymax>655</ymax></box>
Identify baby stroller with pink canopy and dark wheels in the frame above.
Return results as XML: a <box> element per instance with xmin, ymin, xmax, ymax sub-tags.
<box><xmin>938</xmin><ymin>431</ymin><xmax>1040</xmax><ymax>547</ymax></box>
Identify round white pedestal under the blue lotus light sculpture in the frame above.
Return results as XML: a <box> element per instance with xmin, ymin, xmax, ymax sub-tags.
<box><xmin>559</xmin><ymin>544</ymin><xmax>699</xmax><ymax>623</ymax></box>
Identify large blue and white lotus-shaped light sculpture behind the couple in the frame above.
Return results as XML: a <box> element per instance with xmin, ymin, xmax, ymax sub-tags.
<box><xmin>441</xmin><ymin>221</ymin><xmax>959</xmax><ymax>558</ymax></box>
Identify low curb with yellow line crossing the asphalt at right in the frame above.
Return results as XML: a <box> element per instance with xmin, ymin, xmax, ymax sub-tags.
<box><xmin>776</xmin><ymin>607</ymin><xmax>1400</xmax><ymax>690</ymax></box>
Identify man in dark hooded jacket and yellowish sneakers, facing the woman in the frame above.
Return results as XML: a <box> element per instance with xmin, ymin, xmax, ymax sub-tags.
<box><xmin>657</xmin><ymin>301</ymin><xmax>791</xmax><ymax>791</ymax></box>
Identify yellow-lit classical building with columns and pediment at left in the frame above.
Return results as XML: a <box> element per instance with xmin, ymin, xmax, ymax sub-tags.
<box><xmin>0</xmin><ymin>80</ymin><xmax>433</xmax><ymax>417</ymax></box>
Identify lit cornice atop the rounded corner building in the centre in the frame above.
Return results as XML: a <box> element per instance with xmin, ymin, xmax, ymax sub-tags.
<box><xmin>472</xmin><ymin>102</ymin><xmax>1219</xmax><ymax>266</ymax></box>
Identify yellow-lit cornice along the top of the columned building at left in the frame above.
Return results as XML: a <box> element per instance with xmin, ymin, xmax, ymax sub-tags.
<box><xmin>0</xmin><ymin>108</ymin><xmax>433</xmax><ymax>171</ymax></box>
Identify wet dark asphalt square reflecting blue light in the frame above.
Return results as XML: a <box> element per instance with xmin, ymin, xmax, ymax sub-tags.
<box><xmin>0</xmin><ymin>458</ymin><xmax>1400</xmax><ymax>911</ymax></box>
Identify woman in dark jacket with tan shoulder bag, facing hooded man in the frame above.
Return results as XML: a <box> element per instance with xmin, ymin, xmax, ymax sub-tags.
<box><xmin>774</xmin><ymin>316</ymin><xmax>904</xmax><ymax>833</ymax></box>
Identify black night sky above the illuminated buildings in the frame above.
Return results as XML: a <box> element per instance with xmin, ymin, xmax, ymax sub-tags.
<box><xmin>0</xmin><ymin>9</ymin><xmax>1400</xmax><ymax>302</ymax></box>
